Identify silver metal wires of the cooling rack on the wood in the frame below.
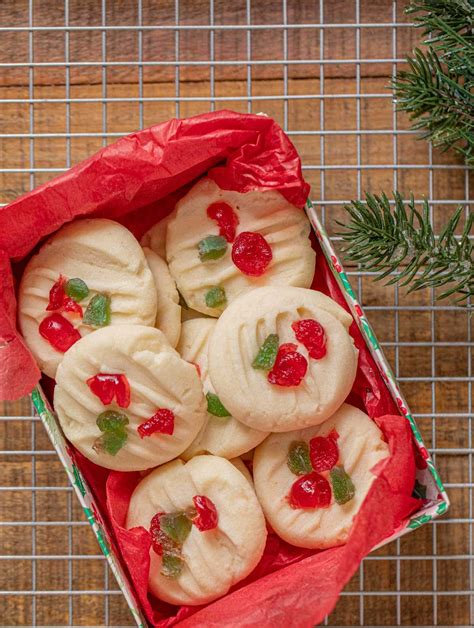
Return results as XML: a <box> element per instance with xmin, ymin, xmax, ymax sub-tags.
<box><xmin>0</xmin><ymin>0</ymin><xmax>474</xmax><ymax>625</ymax></box>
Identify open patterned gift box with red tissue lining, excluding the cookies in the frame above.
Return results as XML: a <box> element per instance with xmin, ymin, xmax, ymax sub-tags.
<box><xmin>0</xmin><ymin>111</ymin><xmax>449</xmax><ymax>626</ymax></box>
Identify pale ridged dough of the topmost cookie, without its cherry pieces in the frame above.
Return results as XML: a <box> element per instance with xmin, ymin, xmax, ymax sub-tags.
<box><xmin>166</xmin><ymin>178</ymin><xmax>315</xmax><ymax>317</ymax></box>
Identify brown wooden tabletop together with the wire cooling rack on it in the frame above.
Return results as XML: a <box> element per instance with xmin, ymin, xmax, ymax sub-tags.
<box><xmin>0</xmin><ymin>0</ymin><xmax>474</xmax><ymax>626</ymax></box>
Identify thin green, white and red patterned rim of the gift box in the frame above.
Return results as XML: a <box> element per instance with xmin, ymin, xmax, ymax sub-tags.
<box><xmin>31</xmin><ymin>201</ymin><xmax>449</xmax><ymax>628</ymax></box>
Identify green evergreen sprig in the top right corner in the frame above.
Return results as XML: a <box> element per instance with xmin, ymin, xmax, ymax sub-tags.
<box><xmin>392</xmin><ymin>0</ymin><xmax>474</xmax><ymax>163</ymax></box>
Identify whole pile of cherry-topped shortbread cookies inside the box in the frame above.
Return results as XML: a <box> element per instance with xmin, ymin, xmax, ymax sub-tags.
<box><xmin>19</xmin><ymin>178</ymin><xmax>388</xmax><ymax>604</ymax></box>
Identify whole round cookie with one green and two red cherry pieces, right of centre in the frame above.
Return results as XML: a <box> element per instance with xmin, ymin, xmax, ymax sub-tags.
<box><xmin>208</xmin><ymin>287</ymin><xmax>358</xmax><ymax>432</ymax></box>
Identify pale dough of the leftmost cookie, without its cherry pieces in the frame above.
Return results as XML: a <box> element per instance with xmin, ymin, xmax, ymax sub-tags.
<box><xmin>18</xmin><ymin>218</ymin><xmax>157</xmax><ymax>378</ymax></box>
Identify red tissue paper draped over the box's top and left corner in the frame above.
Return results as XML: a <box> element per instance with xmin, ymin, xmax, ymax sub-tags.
<box><xmin>0</xmin><ymin>111</ymin><xmax>309</xmax><ymax>400</ymax></box>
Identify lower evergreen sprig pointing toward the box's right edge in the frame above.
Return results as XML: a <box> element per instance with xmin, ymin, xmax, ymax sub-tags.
<box><xmin>338</xmin><ymin>192</ymin><xmax>474</xmax><ymax>302</ymax></box>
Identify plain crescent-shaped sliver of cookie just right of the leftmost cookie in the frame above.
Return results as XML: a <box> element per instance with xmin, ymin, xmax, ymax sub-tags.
<box><xmin>143</xmin><ymin>247</ymin><xmax>181</xmax><ymax>347</ymax></box>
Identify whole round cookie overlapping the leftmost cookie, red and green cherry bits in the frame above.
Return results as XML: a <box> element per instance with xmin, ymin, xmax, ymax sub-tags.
<box><xmin>54</xmin><ymin>325</ymin><xmax>206</xmax><ymax>471</ymax></box>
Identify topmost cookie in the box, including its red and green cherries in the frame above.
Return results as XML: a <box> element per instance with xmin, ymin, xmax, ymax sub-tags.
<box><xmin>166</xmin><ymin>178</ymin><xmax>315</xmax><ymax>316</ymax></box>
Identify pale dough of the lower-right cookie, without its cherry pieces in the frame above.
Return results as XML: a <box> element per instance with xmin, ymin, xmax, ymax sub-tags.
<box><xmin>253</xmin><ymin>404</ymin><xmax>389</xmax><ymax>549</ymax></box>
